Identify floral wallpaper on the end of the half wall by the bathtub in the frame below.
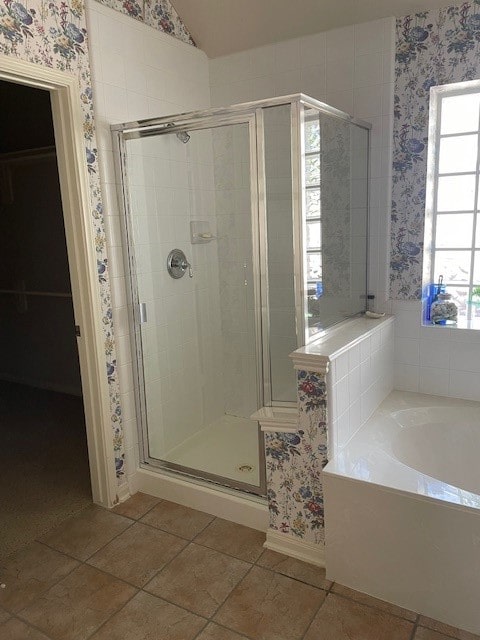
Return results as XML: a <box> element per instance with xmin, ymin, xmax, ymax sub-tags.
<box><xmin>265</xmin><ymin>371</ymin><xmax>327</xmax><ymax>544</ymax></box>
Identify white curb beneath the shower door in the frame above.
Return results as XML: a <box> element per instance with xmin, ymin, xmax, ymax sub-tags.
<box><xmin>135</xmin><ymin>468</ymin><xmax>268</xmax><ymax>531</ymax></box>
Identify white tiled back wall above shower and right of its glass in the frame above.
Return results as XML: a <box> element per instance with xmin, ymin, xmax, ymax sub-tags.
<box><xmin>210</xmin><ymin>18</ymin><xmax>395</xmax><ymax>309</ymax></box>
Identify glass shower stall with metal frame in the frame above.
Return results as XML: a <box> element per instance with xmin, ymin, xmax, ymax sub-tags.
<box><xmin>112</xmin><ymin>94</ymin><xmax>369</xmax><ymax>495</ymax></box>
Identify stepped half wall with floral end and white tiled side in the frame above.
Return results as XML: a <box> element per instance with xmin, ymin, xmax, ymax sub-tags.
<box><xmin>261</xmin><ymin>317</ymin><xmax>394</xmax><ymax>565</ymax></box>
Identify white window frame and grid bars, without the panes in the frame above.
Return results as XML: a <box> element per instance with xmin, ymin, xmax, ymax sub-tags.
<box><xmin>423</xmin><ymin>80</ymin><xmax>480</xmax><ymax>329</ymax></box>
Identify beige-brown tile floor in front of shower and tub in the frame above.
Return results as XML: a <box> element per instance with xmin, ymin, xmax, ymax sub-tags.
<box><xmin>0</xmin><ymin>493</ymin><xmax>479</xmax><ymax>640</ymax></box>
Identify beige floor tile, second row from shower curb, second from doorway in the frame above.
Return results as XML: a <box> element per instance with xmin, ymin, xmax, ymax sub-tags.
<box><xmin>88</xmin><ymin>522</ymin><xmax>188</xmax><ymax>587</ymax></box>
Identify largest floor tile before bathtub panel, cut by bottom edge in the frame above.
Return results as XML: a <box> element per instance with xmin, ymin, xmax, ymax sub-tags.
<box><xmin>305</xmin><ymin>594</ymin><xmax>413</xmax><ymax>640</ymax></box>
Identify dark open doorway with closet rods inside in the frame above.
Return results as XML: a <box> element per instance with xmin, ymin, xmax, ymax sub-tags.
<box><xmin>0</xmin><ymin>81</ymin><xmax>92</xmax><ymax>557</ymax></box>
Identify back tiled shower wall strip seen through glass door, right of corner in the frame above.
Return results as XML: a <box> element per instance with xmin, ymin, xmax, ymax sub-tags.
<box><xmin>213</xmin><ymin>124</ymin><xmax>258</xmax><ymax>418</ymax></box>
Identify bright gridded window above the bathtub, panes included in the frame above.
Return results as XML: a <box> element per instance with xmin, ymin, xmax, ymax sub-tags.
<box><xmin>424</xmin><ymin>81</ymin><xmax>480</xmax><ymax>329</ymax></box>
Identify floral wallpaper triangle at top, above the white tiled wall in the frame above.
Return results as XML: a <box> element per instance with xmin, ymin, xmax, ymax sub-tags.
<box><xmin>97</xmin><ymin>0</ymin><xmax>196</xmax><ymax>46</ymax></box>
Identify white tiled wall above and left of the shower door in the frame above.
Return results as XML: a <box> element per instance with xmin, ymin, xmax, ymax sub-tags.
<box><xmin>87</xmin><ymin>0</ymin><xmax>210</xmax><ymax>491</ymax></box>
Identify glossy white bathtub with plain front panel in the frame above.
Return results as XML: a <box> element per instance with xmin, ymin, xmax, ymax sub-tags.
<box><xmin>323</xmin><ymin>391</ymin><xmax>480</xmax><ymax>633</ymax></box>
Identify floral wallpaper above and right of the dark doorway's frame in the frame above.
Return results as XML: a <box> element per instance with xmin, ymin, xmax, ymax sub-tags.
<box><xmin>0</xmin><ymin>0</ymin><xmax>124</xmax><ymax>483</ymax></box>
